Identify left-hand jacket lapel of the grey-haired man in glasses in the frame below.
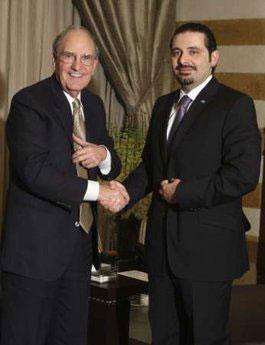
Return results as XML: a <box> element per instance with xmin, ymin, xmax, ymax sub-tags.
<box><xmin>51</xmin><ymin>75</ymin><xmax>73</xmax><ymax>144</ymax></box>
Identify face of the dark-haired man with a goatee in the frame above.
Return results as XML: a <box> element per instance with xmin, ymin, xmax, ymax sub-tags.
<box><xmin>171</xmin><ymin>31</ymin><xmax>219</xmax><ymax>91</ymax></box>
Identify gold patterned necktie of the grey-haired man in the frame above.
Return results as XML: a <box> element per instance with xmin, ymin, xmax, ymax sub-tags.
<box><xmin>73</xmin><ymin>98</ymin><xmax>93</xmax><ymax>233</ymax></box>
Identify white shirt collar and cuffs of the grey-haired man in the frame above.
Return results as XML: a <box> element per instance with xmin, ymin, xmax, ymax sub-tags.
<box><xmin>63</xmin><ymin>91</ymin><xmax>111</xmax><ymax>201</ymax></box>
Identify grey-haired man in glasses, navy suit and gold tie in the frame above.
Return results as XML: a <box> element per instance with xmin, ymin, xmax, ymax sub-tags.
<box><xmin>1</xmin><ymin>27</ymin><xmax>126</xmax><ymax>345</ymax></box>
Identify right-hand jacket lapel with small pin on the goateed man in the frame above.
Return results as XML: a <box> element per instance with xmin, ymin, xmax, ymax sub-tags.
<box><xmin>169</xmin><ymin>78</ymin><xmax>219</xmax><ymax>153</ymax></box>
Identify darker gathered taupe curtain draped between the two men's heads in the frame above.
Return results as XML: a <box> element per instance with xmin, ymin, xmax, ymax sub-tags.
<box><xmin>73</xmin><ymin>0</ymin><xmax>176</xmax><ymax>127</ymax></box>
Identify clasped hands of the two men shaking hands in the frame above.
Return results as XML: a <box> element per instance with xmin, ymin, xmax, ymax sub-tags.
<box><xmin>98</xmin><ymin>181</ymin><xmax>130</xmax><ymax>213</ymax></box>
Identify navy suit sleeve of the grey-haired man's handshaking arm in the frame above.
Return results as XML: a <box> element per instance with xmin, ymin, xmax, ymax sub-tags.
<box><xmin>6</xmin><ymin>96</ymin><xmax>87</xmax><ymax>206</ymax></box>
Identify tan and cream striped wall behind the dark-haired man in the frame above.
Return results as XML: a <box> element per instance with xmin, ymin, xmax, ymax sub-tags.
<box><xmin>176</xmin><ymin>0</ymin><xmax>265</xmax><ymax>238</ymax></box>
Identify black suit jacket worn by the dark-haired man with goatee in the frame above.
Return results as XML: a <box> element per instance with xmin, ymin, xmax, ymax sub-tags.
<box><xmin>124</xmin><ymin>78</ymin><xmax>261</xmax><ymax>280</ymax></box>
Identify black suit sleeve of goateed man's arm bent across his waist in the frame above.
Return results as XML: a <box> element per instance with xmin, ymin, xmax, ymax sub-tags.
<box><xmin>176</xmin><ymin>96</ymin><xmax>261</xmax><ymax>209</ymax></box>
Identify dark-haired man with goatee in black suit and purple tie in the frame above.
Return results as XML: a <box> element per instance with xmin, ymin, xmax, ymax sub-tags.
<box><xmin>102</xmin><ymin>23</ymin><xmax>261</xmax><ymax>345</ymax></box>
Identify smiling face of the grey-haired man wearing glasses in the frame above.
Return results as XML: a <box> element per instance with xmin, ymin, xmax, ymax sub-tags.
<box><xmin>53</xmin><ymin>30</ymin><xmax>98</xmax><ymax>98</ymax></box>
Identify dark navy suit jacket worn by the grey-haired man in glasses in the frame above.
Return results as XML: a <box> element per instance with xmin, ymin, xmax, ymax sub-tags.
<box><xmin>1</xmin><ymin>76</ymin><xmax>120</xmax><ymax>280</ymax></box>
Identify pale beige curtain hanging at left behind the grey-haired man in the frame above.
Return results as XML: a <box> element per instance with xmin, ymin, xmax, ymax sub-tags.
<box><xmin>0</xmin><ymin>0</ymin><xmax>80</xmax><ymax>225</ymax></box>
